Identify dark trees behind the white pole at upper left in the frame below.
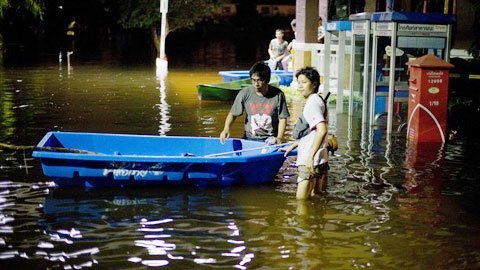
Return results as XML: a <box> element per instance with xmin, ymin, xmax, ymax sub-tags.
<box><xmin>0</xmin><ymin>0</ymin><xmax>222</xmax><ymax>60</ymax></box>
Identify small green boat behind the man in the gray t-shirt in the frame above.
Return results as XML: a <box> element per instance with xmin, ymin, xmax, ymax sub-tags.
<box><xmin>197</xmin><ymin>74</ymin><xmax>280</xmax><ymax>101</ymax></box>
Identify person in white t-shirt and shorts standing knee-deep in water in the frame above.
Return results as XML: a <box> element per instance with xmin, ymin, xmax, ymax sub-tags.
<box><xmin>283</xmin><ymin>67</ymin><xmax>328</xmax><ymax>200</ymax></box>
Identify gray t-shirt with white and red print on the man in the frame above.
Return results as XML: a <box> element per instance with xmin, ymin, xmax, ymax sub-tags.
<box><xmin>230</xmin><ymin>85</ymin><xmax>290</xmax><ymax>140</ymax></box>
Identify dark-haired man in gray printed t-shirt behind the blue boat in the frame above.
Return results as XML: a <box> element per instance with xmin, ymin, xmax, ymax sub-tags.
<box><xmin>220</xmin><ymin>62</ymin><xmax>290</xmax><ymax>143</ymax></box>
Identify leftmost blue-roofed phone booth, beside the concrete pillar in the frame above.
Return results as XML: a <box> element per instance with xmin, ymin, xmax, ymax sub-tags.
<box><xmin>323</xmin><ymin>21</ymin><xmax>352</xmax><ymax>113</ymax></box>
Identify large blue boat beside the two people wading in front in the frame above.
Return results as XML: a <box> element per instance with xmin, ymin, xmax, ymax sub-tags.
<box><xmin>33</xmin><ymin>132</ymin><xmax>292</xmax><ymax>187</ymax></box>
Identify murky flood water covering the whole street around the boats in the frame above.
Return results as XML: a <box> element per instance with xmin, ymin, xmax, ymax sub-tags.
<box><xmin>0</xmin><ymin>43</ymin><xmax>480</xmax><ymax>269</ymax></box>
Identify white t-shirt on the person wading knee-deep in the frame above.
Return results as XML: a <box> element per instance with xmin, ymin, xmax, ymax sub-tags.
<box><xmin>297</xmin><ymin>94</ymin><xmax>328</xmax><ymax>166</ymax></box>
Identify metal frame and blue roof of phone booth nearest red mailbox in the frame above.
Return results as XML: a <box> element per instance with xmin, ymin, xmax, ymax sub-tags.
<box><xmin>370</xmin><ymin>12</ymin><xmax>455</xmax><ymax>135</ymax></box>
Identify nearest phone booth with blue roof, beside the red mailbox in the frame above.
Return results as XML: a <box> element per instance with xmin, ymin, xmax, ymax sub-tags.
<box><xmin>370</xmin><ymin>12</ymin><xmax>455</xmax><ymax>135</ymax></box>
